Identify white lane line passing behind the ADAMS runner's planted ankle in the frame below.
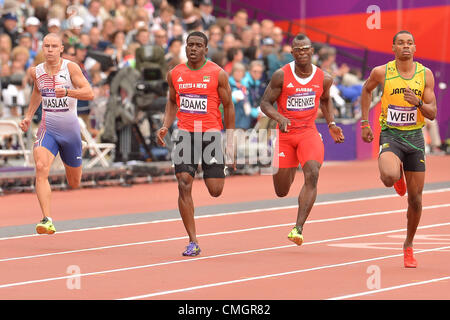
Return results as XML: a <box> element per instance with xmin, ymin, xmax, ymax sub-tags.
<box><xmin>0</xmin><ymin>204</ymin><xmax>450</xmax><ymax>263</ymax></box>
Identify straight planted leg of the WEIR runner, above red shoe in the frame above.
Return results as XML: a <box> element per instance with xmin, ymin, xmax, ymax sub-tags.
<box><xmin>403</xmin><ymin>171</ymin><xmax>425</xmax><ymax>249</ymax></box>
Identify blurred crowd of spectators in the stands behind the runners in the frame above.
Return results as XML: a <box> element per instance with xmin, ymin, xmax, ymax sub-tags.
<box><xmin>0</xmin><ymin>0</ymin><xmax>398</xmax><ymax>161</ymax></box>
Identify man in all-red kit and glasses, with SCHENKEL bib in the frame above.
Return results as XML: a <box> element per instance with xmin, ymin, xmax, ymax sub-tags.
<box><xmin>261</xmin><ymin>34</ymin><xmax>344</xmax><ymax>245</ymax></box>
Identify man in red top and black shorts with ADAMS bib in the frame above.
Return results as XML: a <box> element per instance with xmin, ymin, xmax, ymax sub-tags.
<box><xmin>157</xmin><ymin>31</ymin><xmax>235</xmax><ymax>256</ymax></box>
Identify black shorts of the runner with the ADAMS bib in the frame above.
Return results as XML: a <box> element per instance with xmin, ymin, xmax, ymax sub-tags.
<box><xmin>172</xmin><ymin>130</ymin><xmax>225</xmax><ymax>179</ymax></box>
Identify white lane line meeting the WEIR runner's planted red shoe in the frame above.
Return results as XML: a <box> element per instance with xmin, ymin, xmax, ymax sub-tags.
<box><xmin>118</xmin><ymin>246</ymin><xmax>450</xmax><ymax>300</ymax></box>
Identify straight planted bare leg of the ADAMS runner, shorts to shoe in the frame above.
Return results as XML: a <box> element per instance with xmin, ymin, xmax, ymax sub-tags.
<box><xmin>175</xmin><ymin>172</ymin><xmax>198</xmax><ymax>243</ymax></box>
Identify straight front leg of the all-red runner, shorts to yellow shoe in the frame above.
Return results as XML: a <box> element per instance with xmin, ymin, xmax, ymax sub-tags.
<box><xmin>296</xmin><ymin>160</ymin><xmax>321</xmax><ymax>231</ymax></box>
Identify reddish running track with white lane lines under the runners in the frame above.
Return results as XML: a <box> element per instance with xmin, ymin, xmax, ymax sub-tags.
<box><xmin>0</xmin><ymin>156</ymin><xmax>450</xmax><ymax>300</ymax></box>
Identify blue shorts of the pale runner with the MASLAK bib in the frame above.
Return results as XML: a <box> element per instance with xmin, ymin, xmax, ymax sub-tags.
<box><xmin>34</xmin><ymin>126</ymin><xmax>82</xmax><ymax>167</ymax></box>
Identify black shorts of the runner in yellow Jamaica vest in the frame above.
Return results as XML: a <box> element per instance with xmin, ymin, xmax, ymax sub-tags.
<box><xmin>379</xmin><ymin>128</ymin><xmax>425</xmax><ymax>172</ymax></box>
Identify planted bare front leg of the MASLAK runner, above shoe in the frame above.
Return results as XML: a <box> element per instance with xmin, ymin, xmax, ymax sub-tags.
<box><xmin>33</xmin><ymin>146</ymin><xmax>55</xmax><ymax>218</ymax></box>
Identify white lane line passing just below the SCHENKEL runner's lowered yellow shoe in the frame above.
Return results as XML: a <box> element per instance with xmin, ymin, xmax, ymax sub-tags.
<box><xmin>0</xmin><ymin>222</ymin><xmax>450</xmax><ymax>289</ymax></box>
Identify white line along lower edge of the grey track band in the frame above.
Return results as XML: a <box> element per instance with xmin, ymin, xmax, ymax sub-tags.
<box><xmin>0</xmin><ymin>188</ymin><xmax>450</xmax><ymax>241</ymax></box>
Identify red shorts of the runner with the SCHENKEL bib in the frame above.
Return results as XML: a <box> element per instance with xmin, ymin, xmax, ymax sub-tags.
<box><xmin>273</xmin><ymin>128</ymin><xmax>324</xmax><ymax>168</ymax></box>
